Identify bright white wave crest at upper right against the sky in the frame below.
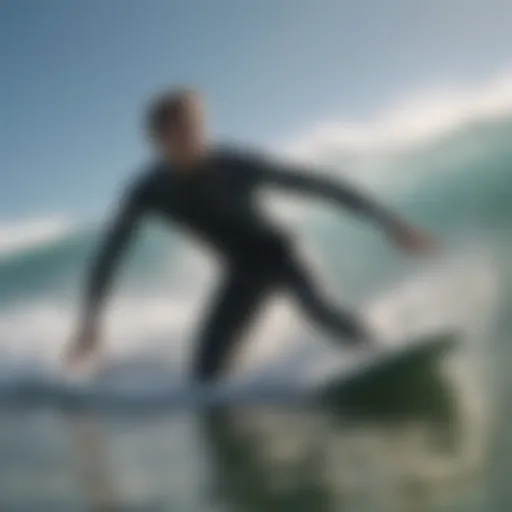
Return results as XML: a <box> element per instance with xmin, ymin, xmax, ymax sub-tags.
<box><xmin>277</xmin><ymin>73</ymin><xmax>512</xmax><ymax>159</ymax></box>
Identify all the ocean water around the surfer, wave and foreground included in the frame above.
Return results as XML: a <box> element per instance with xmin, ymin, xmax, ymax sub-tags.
<box><xmin>0</xmin><ymin>91</ymin><xmax>512</xmax><ymax>512</ymax></box>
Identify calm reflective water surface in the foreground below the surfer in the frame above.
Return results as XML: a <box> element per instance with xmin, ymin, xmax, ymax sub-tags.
<box><xmin>0</xmin><ymin>360</ymin><xmax>487</xmax><ymax>512</ymax></box>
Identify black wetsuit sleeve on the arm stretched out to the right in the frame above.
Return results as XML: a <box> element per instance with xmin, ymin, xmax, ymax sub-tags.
<box><xmin>252</xmin><ymin>153</ymin><xmax>399</xmax><ymax>229</ymax></box>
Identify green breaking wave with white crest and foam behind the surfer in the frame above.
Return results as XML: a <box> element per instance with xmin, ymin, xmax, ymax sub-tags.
<box><xmin>0</xmin><ymin>77</ymin><xmax>512</xmax><ymax>408</ymax></box>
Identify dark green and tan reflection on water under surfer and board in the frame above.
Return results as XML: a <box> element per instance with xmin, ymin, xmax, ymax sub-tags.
<box><xmin>203</xmin><ymin>362</ymin><xmax>481</xmax><ymax>512</ymax></box>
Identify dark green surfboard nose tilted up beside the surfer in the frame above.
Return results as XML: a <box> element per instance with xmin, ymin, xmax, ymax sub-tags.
<box><xmin>316</xmin><ymin>332</ymin><xmax>460</xmax><ymax>407</ymax></box>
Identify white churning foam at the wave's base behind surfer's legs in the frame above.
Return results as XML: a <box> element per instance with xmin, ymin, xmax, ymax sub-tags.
<box><xmin>0</xmin><ymin>242</ymin><xmax>497</xmax><ymax>390</ymax></box>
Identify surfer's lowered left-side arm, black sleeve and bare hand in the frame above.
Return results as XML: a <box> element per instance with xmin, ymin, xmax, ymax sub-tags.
<box><xmin>69</xmin><ymin>188</ymin><xmax>141</xmax><ymax>364</ymax></box>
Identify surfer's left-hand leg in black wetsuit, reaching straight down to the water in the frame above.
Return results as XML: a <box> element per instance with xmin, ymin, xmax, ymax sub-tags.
<box><xmin>193</xmin><ymin>269</ymin><xmax>270</xmax><ymax>381</ymax></box>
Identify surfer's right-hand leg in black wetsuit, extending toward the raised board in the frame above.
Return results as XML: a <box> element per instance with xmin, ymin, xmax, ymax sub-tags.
<box><xmin>284</xmin><ymin>252</ymin><xmax>370</xmax><ymax>344</ymax></box>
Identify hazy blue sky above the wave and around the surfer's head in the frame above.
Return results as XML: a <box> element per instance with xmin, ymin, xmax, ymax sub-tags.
<box><xmin>0</xmin><ymin>0</ymin><xmax>512</xmax><ymax>220</ymax></box>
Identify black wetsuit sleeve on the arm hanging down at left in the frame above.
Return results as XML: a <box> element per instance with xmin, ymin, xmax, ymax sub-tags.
<box><xmin>84</xmin><ymin>182</ymin><xmax>144</xmax><ymax>321</ymax></box>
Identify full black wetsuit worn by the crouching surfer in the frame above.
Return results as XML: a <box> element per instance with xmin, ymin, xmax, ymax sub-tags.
<box><xmin>86</xmin><ymin>149</ymin><xmax>395</xmax><ymax>380</ymax></box>
